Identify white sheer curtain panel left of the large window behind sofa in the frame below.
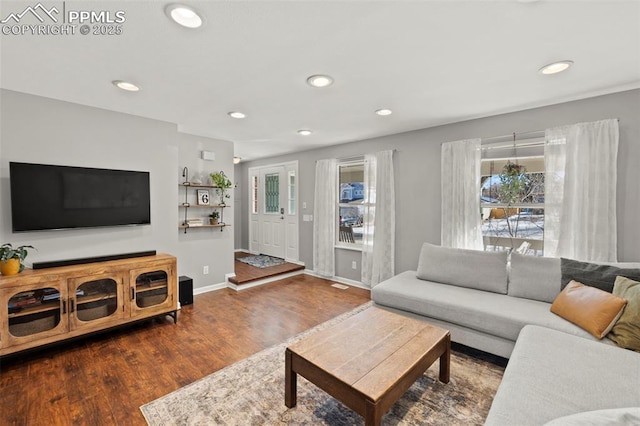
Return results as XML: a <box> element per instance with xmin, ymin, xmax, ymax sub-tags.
<box><xmin>441</xmin><ymin>139</ymin><xmax>484</xmax><ymax>250</ymax></box>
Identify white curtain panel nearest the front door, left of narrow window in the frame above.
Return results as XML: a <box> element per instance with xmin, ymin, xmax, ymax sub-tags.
<box><xmin>313</xmin><ymin>158</ymin><xmax>338</xmax><ymax>277</ymax></box>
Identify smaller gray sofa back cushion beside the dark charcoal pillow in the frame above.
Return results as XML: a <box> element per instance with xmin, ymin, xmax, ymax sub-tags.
<box><xmin>508</xmin><ymin>252</ymin><xmax>560</xmax><ymax>303</ymax></box>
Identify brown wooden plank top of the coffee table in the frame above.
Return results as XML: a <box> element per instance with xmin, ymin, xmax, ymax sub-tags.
<box><xmin>288</xmin><ymin>306</ymin><xmax>449</xmax><ymax>401</ymax></box>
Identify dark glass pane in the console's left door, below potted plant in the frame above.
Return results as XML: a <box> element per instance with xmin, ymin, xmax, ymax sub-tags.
<box><xmin>7</xmin><ymin>287</ymin><xmax>60</xmax><ymax>337</ymax></box>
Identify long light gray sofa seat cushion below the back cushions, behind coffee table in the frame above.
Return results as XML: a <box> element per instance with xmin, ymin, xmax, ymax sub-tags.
<box><xmin>371</xmin><ymin>271</ymin><xmax>613</xmax><ymax>344</ymax></box>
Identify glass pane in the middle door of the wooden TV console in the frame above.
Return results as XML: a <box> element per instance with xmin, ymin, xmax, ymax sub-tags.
<box><xmin>76</xmin><ymin>278</ymin><xmax>118</xmax><ymax>321</ymax></box>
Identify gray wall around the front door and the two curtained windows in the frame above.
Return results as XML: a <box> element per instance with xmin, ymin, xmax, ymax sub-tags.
<box><xmin>236</xmin><ymin>90</ymin><xmax>640</xmax><ymax>280</ymax></box>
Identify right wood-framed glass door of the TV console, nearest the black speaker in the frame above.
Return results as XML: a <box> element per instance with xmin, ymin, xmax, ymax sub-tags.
<box><xmin>129</xmin><ymin>266</ymin><xmax>174</xmax><ymax>317</ymax></box>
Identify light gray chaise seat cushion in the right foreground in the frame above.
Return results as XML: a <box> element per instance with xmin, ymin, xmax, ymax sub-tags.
<box><xmin>485</xmin><ymin>326</ymin><xmax>640</xmax><ymax>426</ymax></box>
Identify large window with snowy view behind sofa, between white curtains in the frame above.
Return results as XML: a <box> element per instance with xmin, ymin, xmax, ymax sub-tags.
<box><xmin>480</xmin><ymin>147</ymin><xmax>545</xmax><ymax>256</ymax></box>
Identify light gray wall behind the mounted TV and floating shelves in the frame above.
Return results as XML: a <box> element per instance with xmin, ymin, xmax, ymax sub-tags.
<box><xmin>0</xmin><ymin>90</ymin><xmax>235</xmax><ymax>287</ymax></box>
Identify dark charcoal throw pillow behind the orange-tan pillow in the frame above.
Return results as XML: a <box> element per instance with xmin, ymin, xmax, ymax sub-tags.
<box><xmin>560</xmin><ymin>257</ymin><xmax>640</xmax><ymax>293</ymax></box>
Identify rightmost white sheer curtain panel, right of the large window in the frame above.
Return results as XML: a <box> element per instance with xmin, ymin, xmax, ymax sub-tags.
<box><xmin>544</xmin><ymin>119</ymin><xmax>619</xmax><ymax>262</ymax></box>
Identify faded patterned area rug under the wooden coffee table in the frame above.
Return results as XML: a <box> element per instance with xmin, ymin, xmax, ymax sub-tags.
<box><xmin>140</xmin><ymin>302</ymin><xmax>504</xmax><ymax>426</ymax></box>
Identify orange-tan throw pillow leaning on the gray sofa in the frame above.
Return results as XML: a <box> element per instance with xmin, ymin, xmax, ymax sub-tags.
<box><xmin>551</xmin><ymin>281</ymin><xmax>627</xmax><ymax>339</ymax></box>
